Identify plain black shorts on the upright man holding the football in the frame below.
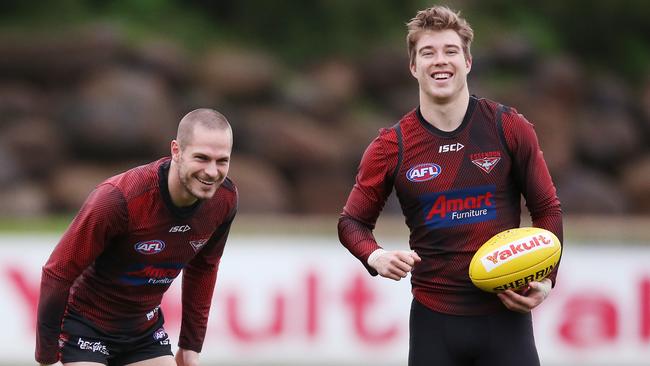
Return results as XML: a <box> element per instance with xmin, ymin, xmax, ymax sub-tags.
<box><xmin>408</xmin><ymin>300</ymin><xmax>539</xmax><ymax>366</ymax></box>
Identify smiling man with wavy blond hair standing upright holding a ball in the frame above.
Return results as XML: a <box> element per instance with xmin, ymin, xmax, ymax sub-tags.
<box><xmin>338</xmin><ymin>6</ymin><xmax>562</xmax><ymax>366</ymax></box>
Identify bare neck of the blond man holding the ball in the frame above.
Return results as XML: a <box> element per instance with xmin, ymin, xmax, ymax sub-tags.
<box><xmin>420</xmin><ymin>90</ymin><xmax>469</xmax><ymax>132</ymax></box>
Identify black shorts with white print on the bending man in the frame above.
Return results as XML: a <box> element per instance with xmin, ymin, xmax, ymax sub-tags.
<box><xmin>59</xmin><ymin>312</ymin><xmax>173</xmax><ymax>366</ymax></box>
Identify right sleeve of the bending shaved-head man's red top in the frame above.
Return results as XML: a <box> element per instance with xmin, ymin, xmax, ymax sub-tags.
<box><xmin>178</xmin><ymin>203</ymin><xmax>236</xmax><ymax>352</ymax></box>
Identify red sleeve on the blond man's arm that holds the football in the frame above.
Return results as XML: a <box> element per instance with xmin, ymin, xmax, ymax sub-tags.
<box><xmin>503</xmin><ymin>111</ymin><xmax>564</xmax><ymax>286</ymax></box>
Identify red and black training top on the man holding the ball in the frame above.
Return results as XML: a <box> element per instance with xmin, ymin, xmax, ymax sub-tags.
<box><xmin>339</xmin><ymin>96</ymin><xmax>562</xmax><ymax>315</ymax></box>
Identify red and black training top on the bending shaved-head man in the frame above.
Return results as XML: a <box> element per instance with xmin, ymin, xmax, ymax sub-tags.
<box><xmin>36</xmin><ymin>158</ymin><xmax>237</xmax><ymax>364</ymax></box>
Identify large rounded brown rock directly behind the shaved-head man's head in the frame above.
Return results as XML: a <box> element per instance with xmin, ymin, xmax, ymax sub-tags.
<box><xmin>60</xmin><ymin>69</ymin><xmax>177</xmax><ymax>160</ymax></box>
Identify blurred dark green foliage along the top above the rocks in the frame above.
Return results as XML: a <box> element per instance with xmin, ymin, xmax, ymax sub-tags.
<box><xmin>0</xmin><ymin>0</ymin><xmax>650</xmax><ymax>83</ymax></box>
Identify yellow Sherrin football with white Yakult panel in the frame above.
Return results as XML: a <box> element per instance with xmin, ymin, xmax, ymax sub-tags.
<box><xmin>469</xmin><ymin>227</ymin><xmax>562</xmax><ymax>292</ymax></box>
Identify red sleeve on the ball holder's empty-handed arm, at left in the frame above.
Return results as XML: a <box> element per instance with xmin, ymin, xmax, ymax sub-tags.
<box><xmin>338</xmin><ymin>130</ymin><xmax>397</xmax><ymax>276</ymax></box>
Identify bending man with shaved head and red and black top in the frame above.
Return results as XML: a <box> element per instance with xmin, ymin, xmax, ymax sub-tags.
<box><xmin>36</xmin><ymin>109</ymin><xmax>237</xmax><ymax>366</ymax></box>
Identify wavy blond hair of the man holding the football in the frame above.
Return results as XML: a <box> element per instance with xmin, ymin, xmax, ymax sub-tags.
<box><xmin>406</xmin><ymin>6</ymin><xmax>474</xmax><ymax>65</ymax></box>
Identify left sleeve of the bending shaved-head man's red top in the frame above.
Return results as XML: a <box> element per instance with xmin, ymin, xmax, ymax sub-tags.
<box><xmin>35</xmin><ymin>184</ymin><xmax>128</xmax><ymax>364</ymax></box>
